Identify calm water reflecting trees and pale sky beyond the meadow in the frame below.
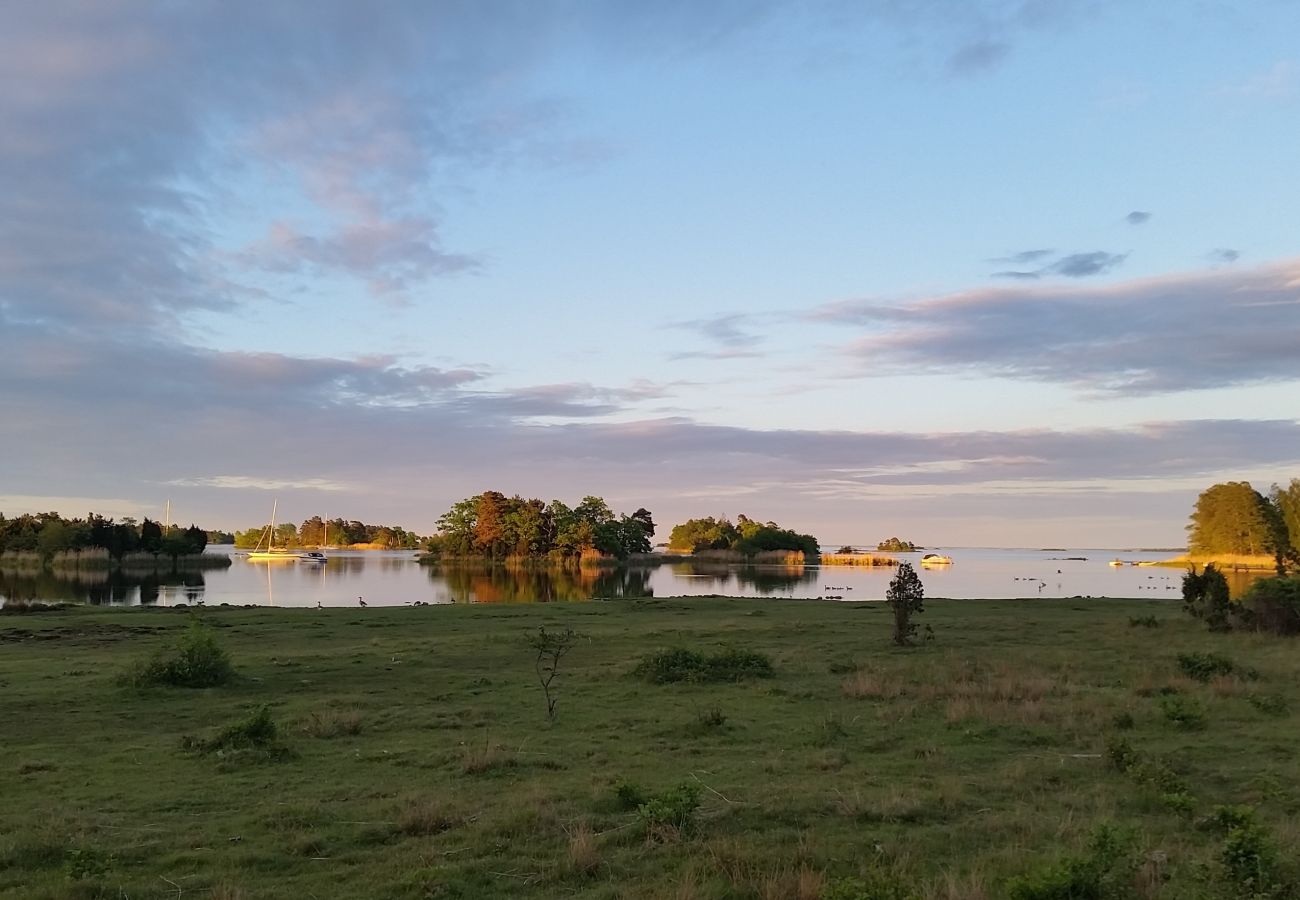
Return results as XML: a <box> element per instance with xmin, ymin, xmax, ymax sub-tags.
<box><xmin>0</xmin><ymin>546</ymin><xmax>1268</xmax><ymax>606</ymax></box>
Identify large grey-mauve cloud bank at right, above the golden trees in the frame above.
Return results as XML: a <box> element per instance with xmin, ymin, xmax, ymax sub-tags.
<box><xmin>811</xmin><ymin>259</ymin><xmax>1300</xmax><ymax>394</ymax></box>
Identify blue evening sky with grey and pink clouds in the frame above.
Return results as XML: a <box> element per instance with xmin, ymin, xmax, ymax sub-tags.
<box><xmin>0</xmin><ymin>0</ymin><xmax>1300</xmax><ymax>548</ymax></box>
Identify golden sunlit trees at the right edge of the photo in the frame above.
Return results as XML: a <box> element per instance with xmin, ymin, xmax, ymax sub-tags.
<box><xmin>1187</xmin><ymin>479</ymin><xmax>1300</xmax><ymax>574</ymax></box>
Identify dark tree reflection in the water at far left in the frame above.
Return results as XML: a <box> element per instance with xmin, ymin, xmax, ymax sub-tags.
<box><xmin>0</xmin><ymin>568</ymin><xmax>207</xmax><ymax>606</ymax></box>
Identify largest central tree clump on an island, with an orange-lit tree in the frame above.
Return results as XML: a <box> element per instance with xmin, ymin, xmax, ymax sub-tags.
<box><xmin>426</xmin><ymin>490</ymin><xmax>655</xmax><ymax>559</ymax></box>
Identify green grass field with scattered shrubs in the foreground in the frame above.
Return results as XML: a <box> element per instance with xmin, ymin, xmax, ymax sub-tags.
<box><xmin>0</xmin><ymin>600</ymin><xmax>1300</xmax><ymax>900</ymax></box>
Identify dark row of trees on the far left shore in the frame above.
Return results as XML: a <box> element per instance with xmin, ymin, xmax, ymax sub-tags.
<box><xmin>0</xmin><ymin>512</ymin><xmax>208</xmax><ymax>561</ymax></box>
